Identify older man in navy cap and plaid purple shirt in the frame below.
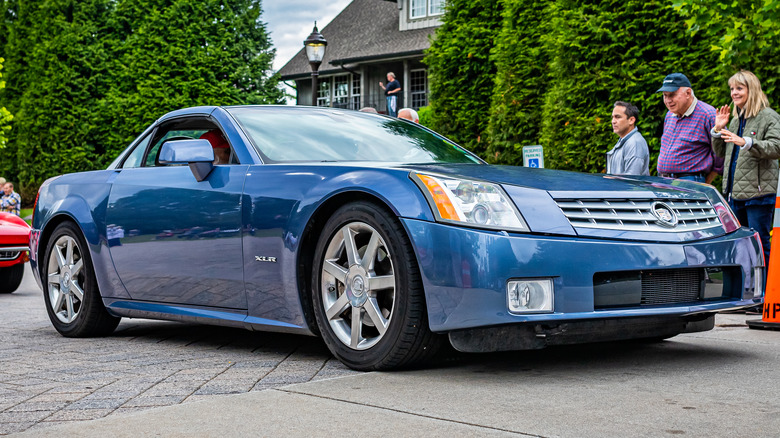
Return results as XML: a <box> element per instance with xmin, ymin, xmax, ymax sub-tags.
<box><xmin>657</xmin><ymin>73</ymin><xmax>721</xmax><ymax>183</ymax></box>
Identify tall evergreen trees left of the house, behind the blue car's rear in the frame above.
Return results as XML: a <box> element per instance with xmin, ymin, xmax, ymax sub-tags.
<box><xmin>0</xmin><ymin>0</ymin><xmax>283</xmax><ymax>203</ymax></box>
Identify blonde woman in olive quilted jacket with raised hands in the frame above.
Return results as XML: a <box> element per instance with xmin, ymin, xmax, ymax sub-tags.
<box><xmin>710</xmin><ymin>70</ymin><xmax>780</xmax><ymax>263</ymax></box>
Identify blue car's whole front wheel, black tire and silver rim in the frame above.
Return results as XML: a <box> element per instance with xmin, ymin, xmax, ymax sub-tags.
<box><xmin>312</xmin><ymin>202</ymin><xmax>446</xmax><ymax>371</ymax></box>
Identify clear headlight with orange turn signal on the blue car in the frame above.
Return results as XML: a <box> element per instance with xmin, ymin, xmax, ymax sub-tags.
<box><xmin>410</xmin><ymin>173</ymin><xmax>529</xmax><ymax>231</ymax></box>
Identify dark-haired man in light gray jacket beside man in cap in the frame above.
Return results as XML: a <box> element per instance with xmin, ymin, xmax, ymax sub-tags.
<box><xmin>607</xmin><ymin>100</ymin><xmax>650</xmax><ymax>175</ymax></box>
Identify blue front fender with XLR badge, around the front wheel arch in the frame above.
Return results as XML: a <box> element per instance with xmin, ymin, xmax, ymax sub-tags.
<box><xmin>238</xmin><ymin>164</ymin><xmax>433</xmax><ymax>326</ymax></box>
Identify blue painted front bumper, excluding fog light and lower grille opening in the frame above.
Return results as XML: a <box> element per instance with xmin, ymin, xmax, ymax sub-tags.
<box><xmin>403</xmin><ymin>219</ymin><xmax>762</xmax><ymax>332</ymax></box>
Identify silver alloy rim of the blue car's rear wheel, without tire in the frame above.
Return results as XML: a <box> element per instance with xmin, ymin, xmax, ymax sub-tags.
<box><xmin>46</xmin><ymin>235</ymin><xmax>84</xmax><ymax>324</ymax></box>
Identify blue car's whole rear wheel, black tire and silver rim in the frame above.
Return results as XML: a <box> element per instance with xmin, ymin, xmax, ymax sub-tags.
<box><xmin>40</xmin><ymin>222</ymin><xmax>121</xmax><ymax>338</ymax></box>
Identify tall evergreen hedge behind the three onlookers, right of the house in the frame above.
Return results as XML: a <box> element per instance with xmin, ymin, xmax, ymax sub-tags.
<box><xmin>425</xmin><ymin>0</ymin><xmax>780</xmax><ymax>173</ymax></box>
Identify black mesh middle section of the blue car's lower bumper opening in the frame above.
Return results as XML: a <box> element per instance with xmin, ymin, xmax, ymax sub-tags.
<box><xmin>641</xmin><ymin>269</ymin><xmax>704</xmax><ymax>306</ymax></box>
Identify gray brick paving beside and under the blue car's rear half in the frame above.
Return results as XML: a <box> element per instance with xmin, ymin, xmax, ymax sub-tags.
<box><xmin>0</xmin><ymin>268</ymin><xmax>356</xmax><ymax>434</ymax></box>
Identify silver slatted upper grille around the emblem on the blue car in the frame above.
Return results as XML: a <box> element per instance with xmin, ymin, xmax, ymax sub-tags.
<box><xmin>555</xmin><ymin>199</ymin><xmax>720</xmax><ymax>233</ymax></box>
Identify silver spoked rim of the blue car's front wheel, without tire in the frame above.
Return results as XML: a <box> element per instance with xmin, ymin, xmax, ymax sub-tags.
<box><xmin>320</xmin><ymin>222</ymin><xmax>395</xmax><ymax>350</ymax></box>
